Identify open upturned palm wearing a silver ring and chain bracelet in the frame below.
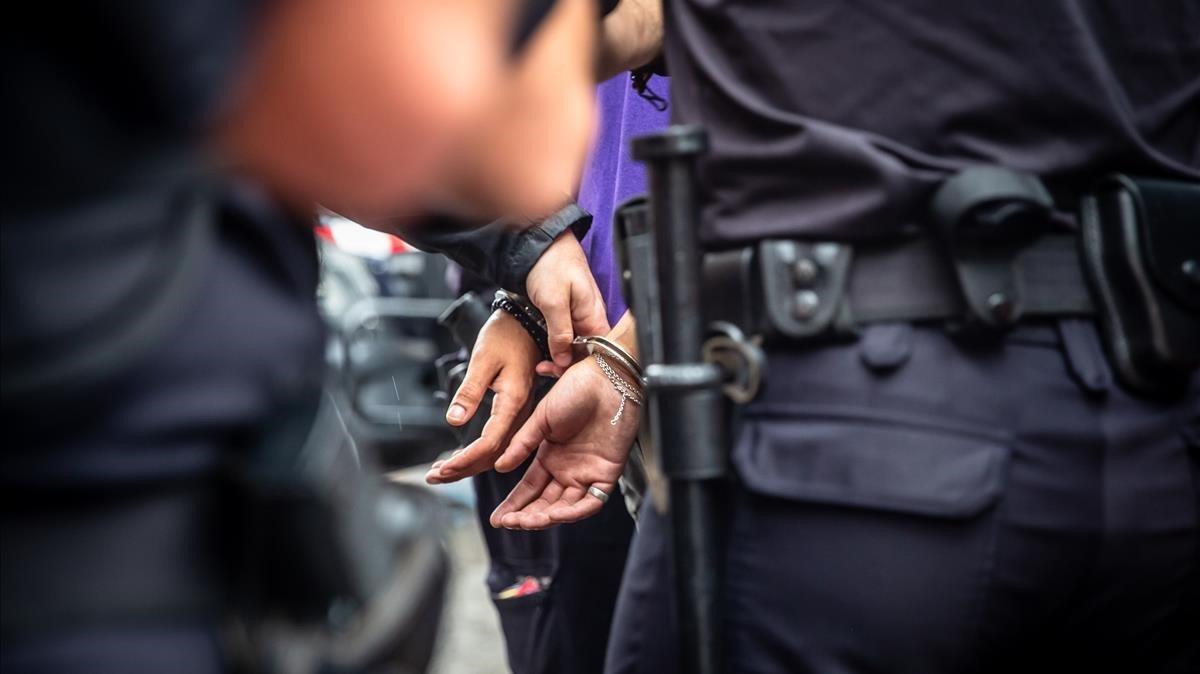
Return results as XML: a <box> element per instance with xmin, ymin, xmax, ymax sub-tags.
<box><xmin>491</xmin><ymin>359</ymin><xmax>641</xmax><ymax>529</ymax></box>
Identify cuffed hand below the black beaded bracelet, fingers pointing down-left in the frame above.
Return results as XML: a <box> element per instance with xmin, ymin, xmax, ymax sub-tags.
<box><xmin>425</xmin><ymin>311</ymin><xmax>541</xmax><ymax>485</ymax></box>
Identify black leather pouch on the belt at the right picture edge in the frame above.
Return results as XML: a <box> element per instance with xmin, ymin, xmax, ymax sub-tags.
<box><xmin>1080</xmin><ymin>175</ymin><xmax>1200</xmax><ymax>397</ymax></box>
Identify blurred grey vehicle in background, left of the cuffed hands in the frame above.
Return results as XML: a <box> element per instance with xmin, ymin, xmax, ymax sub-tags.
<box><xmin>317</xmin><ymin>213</ymin><xmax>458</xmax><ymax>469</ymax></box>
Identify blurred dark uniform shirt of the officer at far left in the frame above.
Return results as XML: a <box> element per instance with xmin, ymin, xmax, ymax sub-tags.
<box><xmin>0</xmin><ymin>0</ymin><xmax>323</xmax><ymax>488</ymax></box>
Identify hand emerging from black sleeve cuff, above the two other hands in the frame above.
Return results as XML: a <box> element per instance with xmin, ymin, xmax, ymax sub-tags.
<box><xmin>526</xmin><ymin>231</ymin><xmax>608</xmax><ymax>366</ymax></box>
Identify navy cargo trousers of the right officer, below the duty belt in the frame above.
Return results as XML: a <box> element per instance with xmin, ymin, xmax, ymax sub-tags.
<box><xmin>607</xmin><ymin>321</ymin><xmax>1200</xmax><ymax>674</ymax></box>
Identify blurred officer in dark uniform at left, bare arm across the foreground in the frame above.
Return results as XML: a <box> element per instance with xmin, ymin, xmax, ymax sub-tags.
<box><xmin>0</xmin><ymin>0</ymin><xmax>594</xmax><ymax>672</ymax></box>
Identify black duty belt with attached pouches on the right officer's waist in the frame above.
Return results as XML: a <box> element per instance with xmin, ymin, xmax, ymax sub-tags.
<box><xmin>617</xmin><ymin>166</ymin><xmax>1200</xmax><ymax>401</ymax></box>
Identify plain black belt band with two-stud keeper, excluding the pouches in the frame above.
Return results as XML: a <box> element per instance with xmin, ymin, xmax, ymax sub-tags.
<box><xmin>704</xmin><ymin>234</ymin><xmax>1094</xmax><ymax>341</ymax></box>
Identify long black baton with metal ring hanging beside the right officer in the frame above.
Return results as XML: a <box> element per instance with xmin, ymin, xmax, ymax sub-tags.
<box><xmin>632</xmin><ymin>126</ymin><xmax>726</xmax><ymax>674</ymax></box>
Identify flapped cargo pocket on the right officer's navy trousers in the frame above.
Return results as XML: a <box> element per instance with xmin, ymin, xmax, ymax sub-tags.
<box><xmin>726</xmin><ymin>410</ymin><xmax>1010</xmax><ymax>672</ymax></box>
